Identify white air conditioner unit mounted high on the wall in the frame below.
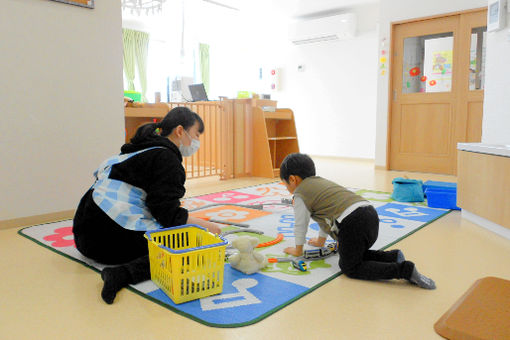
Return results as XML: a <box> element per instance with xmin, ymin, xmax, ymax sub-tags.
<box><xmin>289</xmin><ymin>13</ymin><xmax>356</xmax><ymax>45</ymax></box>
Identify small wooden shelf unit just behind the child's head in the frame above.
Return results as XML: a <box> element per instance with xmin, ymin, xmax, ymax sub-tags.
<box><xmin>252</xmin><ymin>107</ymin><xmax>299</xmax><ymax>177</ymax></box>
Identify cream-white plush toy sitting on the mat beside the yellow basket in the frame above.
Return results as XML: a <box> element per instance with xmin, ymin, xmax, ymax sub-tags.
<box><xmin>228</xmin><ymin>236</ymin><xmax>267</xmax><ymax>274</ymax></box>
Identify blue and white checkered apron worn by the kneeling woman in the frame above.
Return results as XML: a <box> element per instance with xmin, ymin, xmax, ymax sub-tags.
<box><xmin>92</xmin><ymin>147</ymin><xmax>163</xmax><ymax>231</ymax></box>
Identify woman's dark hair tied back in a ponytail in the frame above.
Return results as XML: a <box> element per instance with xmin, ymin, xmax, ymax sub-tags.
<box><xmin>131</xmin><ymin>106</ymin><xmax>204</xmax><ymax>144</ymax></box>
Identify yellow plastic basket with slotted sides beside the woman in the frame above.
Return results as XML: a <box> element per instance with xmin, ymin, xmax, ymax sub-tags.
<box><xmin>145</xmin><ymin>224</ymin><xmax>228</xmax><ymax>304</ymax></box>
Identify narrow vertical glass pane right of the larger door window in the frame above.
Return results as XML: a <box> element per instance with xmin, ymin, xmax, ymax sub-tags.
<box><xmin>469</xmin><ymin>27</ymin><xmax>487</xmax><ymax>90</ymax></box>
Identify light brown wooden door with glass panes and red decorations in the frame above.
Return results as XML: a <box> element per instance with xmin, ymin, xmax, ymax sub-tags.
<box><xmin>388</xmin><ymin>10</ymin><xmax>486</xmax><ymax>174</ymax></box>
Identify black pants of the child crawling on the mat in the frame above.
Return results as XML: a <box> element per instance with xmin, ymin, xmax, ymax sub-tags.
<box><xmin>337</xmin><ymin>206</ymin><xmax>414</xmax><ymax>280</ymax></box>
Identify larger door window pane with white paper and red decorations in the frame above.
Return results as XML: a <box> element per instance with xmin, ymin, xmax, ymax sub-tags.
<box><xmin>402</xmin><ymin>32</ymin><xmax>453</xmax><ymax>93</ymax></box>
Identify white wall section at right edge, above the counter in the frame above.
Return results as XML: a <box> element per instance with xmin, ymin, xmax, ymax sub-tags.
<box><xmin>482</xmin><ymin>9</ymin><xmax>510</xmax><ymax>145</ymax></box>
